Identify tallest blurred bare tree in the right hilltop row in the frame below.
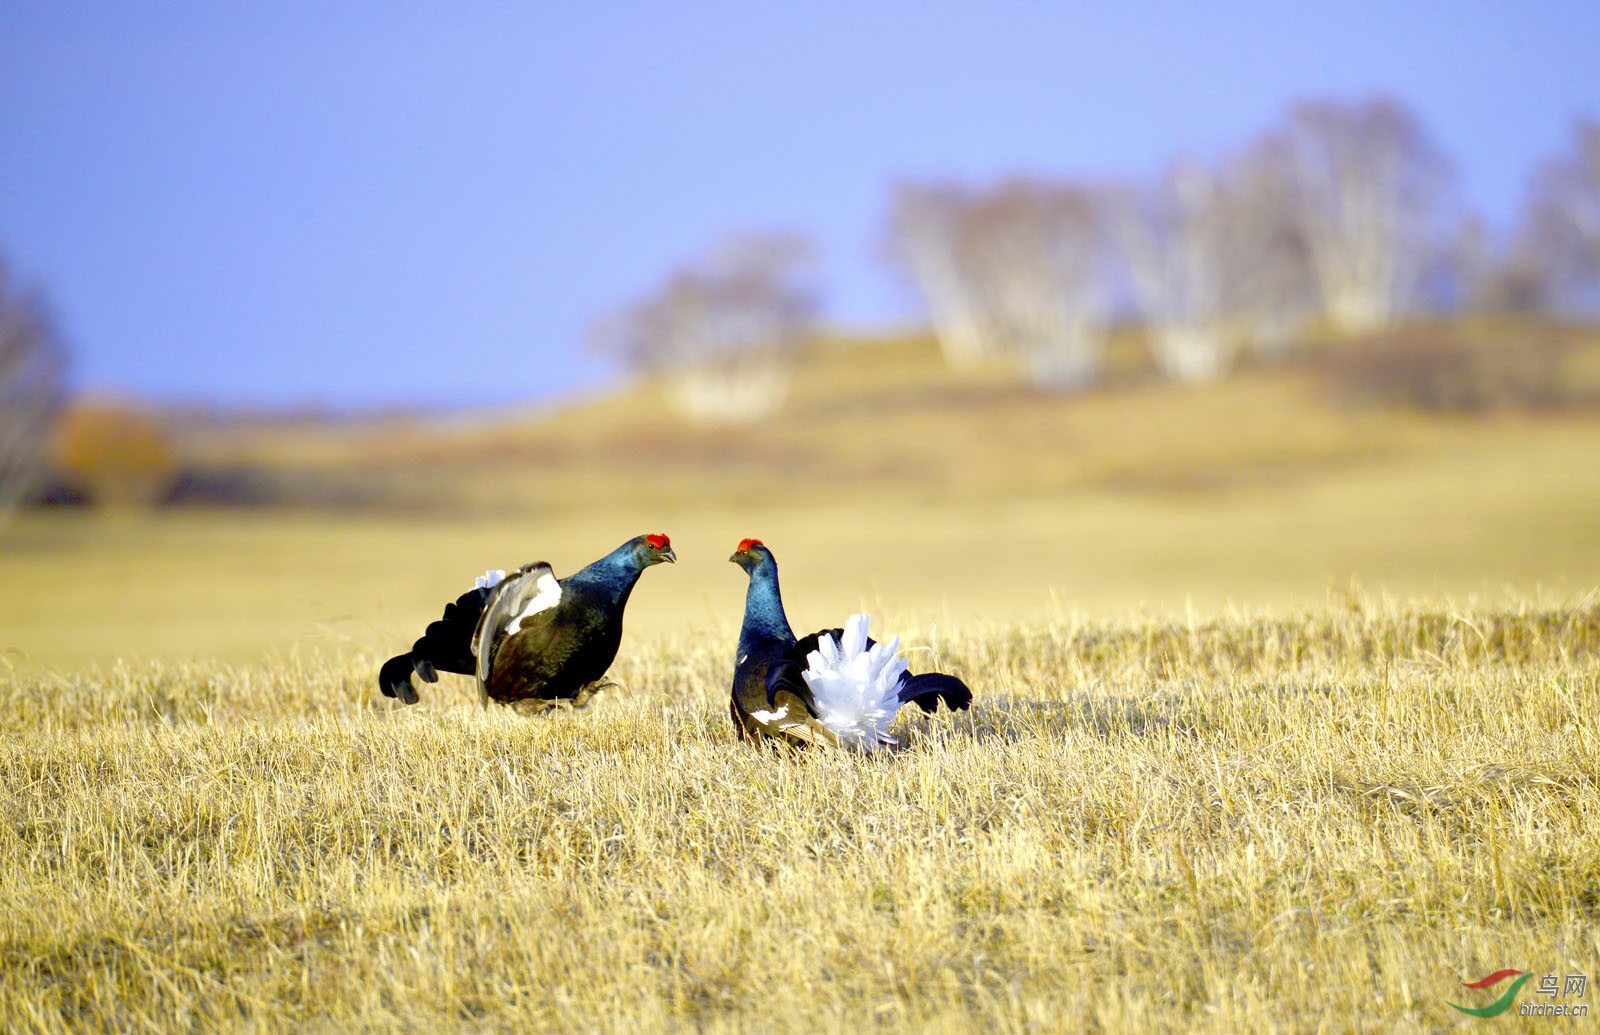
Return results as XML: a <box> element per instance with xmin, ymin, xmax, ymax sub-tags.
<box><xmin>1280</xmin><ymin>99</ymin><xmax>1450</xmax><ymax>333</ymax></box>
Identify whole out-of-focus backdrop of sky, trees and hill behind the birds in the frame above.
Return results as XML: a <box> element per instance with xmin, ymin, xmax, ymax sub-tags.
<box><xmin>0</xmin><ymin>0</ymin><xmax>1600</xmax><ymax>670</ymax></box>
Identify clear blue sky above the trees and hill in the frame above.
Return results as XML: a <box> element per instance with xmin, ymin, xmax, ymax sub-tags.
<box><xmin>0</xmin><ymin>0</ymin><xmax>1600</xmax><ymax>408</ymax></box>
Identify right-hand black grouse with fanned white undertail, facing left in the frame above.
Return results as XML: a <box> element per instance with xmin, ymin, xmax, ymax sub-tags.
<box><xmin>728</xmin><ymin>539</ymin><xmax>973</xmax><ymax>750</ymax></box>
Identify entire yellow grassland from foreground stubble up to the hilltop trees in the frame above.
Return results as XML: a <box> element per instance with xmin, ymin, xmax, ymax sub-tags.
<box><xmin>0</xmin><ymin>329</ymin><xmax>1600</xmax><ymax>1032</ymax></box>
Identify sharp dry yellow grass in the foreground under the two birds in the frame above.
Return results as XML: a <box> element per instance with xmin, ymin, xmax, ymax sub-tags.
<box><xmin>0</xmin><ymin>601</ymin><xmax>1600</xmax><ymax>1032</ymax></box>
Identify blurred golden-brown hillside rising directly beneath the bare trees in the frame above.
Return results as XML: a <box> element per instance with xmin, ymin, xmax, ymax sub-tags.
<box><xmin>159</xmin><ymin>323</ymin><xmax>1600</xmax><ymax>512</ymax></box>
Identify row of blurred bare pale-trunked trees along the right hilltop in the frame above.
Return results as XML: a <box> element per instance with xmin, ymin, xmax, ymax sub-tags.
<box><xmin>888</xmin><ymin>99</ymin><xmax>1600</xmax><ymax>386</ymax></box>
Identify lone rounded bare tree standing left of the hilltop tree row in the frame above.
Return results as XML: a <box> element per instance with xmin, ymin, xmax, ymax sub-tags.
<box><xmin>590</xmin><ymin>234</ymin><xmax>818</xmax><ymax>422</ymax></box>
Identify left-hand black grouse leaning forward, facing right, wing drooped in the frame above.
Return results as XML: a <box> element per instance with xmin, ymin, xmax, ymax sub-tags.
<box><xmin>378</xmin><ymin>534</ymin><xmax>677</xmax><ymax>705</ymax></box>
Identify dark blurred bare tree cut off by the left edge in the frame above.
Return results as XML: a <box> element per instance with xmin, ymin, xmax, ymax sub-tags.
<box><xmin>0</xmin><ymin>259</ymin><xmax>67</xmax><ymax>520</ymax></box>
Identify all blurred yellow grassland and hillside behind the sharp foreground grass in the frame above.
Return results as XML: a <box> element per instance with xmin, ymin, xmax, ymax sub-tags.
<box><xmin>12</xmin><ymin>331</ymin><xmax>1600</xmax><ymax>672</ymax></box>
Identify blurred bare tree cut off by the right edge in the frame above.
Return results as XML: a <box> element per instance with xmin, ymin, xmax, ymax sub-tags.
<box><xmin>1515</xmin><ymin>120</ymin><xmax>1600</xmax><ymax>315</ymax></box>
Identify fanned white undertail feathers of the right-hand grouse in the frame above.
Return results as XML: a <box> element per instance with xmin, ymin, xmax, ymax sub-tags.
<box><xmin>805</xmin><ymin>614</ymin><xmax>906</xmax><ymax>750</ymax></box>
